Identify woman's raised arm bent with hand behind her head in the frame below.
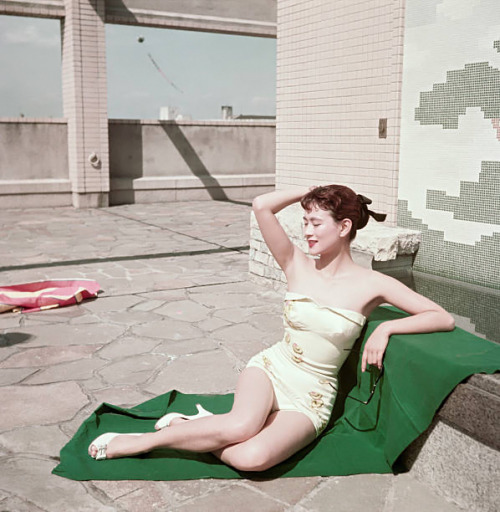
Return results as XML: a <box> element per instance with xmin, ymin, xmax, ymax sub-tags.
<box><xmin>252</xmin><ymin>188</ymin><xmax>309</xmax><ymax>273</ymax></box>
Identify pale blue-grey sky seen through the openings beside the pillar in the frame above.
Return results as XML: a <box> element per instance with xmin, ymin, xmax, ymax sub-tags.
<box><xmin>0</xmin><ymin>16</ymin><xmax>276</xmax><ymax>119</ymax></box>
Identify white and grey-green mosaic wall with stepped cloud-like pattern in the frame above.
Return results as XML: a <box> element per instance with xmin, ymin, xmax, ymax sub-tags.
<box><xmin>398</xmin><ymin>0</ymin><xmax>500</xmax><ymax>288</ymax></box>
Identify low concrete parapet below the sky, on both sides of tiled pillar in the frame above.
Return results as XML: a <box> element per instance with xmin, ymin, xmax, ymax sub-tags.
<box><xmin>0</xmin><ymin>118</ymin><xmax>276</xmax><ymax>208</ymax></box>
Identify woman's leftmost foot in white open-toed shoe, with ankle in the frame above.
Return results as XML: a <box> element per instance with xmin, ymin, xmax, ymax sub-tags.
<box><xmin>88</xmin><ymin>432</ymin><xmax>148</xmax><ymax>460</ymax></box>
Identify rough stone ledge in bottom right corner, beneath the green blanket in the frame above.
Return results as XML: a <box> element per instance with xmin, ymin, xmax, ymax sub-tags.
<box><xmin>401</xmin><ymin>374</ymin><xmax>500</xmax><ymax>512</ymax></box>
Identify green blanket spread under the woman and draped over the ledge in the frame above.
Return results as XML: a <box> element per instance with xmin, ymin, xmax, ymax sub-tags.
<box><xmin>53</xmin><ymin>308</ymin><xmax>500</xmax><ymax>480</ymax></box>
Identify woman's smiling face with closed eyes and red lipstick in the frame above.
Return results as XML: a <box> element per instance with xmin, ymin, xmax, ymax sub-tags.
<box><xmin>304</xmin><ymin>207</ymin><xmax>345</xmax><ymax>256</ymax></box>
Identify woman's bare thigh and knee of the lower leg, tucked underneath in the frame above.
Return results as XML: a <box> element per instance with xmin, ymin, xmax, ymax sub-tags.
<box><xmin>214</xmin><ymin>411</ymin><xmax>316</xmax><ymax>471</ymax></box>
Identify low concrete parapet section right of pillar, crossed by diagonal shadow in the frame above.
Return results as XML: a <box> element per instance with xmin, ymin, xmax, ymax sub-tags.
<box><xmin>109</xmin><ymin>120</ymin><xmax>276</xmax><ymax>204</ymax></box>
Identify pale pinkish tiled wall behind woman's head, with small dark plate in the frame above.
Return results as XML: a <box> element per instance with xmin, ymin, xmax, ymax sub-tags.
<box><xmin>276</xmin><ymin>0</ymin><xmax>404</xmax><ymax>224</ymax></box>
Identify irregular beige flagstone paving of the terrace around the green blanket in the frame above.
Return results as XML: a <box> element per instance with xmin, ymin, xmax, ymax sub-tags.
<box><xmin>0</xmin><ymin>201</ymin><xmax>459</xmax><ymax>512</ymax></box>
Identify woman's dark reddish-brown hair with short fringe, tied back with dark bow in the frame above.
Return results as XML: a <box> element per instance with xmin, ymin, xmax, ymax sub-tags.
<box><xmin>300</xmin><ymin>185</ymin><xmax>386</xmax><ymax>240</ymax></box>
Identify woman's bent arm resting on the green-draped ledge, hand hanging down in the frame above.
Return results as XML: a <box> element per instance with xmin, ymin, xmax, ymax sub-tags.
<box><xmin>361</xmin><ymin>273</ymin><xmax>455</xmax><ymax>372</ymax></box>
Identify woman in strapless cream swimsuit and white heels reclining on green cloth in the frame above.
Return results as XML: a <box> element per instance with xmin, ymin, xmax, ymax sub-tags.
<box><xmin>89</xmin><ymin>185</ymin><xmax>454</xmax><ymax>471</ymax></box>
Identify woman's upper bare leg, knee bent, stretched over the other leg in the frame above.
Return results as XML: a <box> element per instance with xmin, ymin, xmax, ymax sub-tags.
<box><xmin>89</xmin><ymin>367</ymin><xmax>274</xmax><ymax>458</ymax></box>
